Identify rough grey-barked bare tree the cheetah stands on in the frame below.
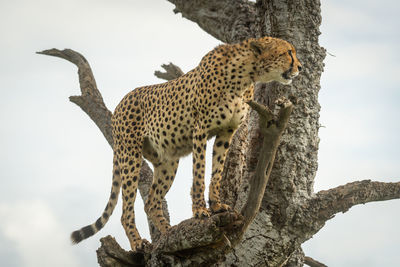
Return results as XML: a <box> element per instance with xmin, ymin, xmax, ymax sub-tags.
<box><xmin>41</xmin><ymin>0</ymin><xmax>400</xmax><ymax>266</ymax></box>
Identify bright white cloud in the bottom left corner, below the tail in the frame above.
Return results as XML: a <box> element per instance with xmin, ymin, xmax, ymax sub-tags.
<box><xmin>0</xmin><ymin>200</ymin><xmax>79</xmax><ymax>267</ymax></box>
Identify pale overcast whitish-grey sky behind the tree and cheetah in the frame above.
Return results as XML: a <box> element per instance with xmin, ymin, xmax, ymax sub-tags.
<box><xmin>0</xmin><ymin>0</ymin><xmax>400</xmax><ymax>267</ymax></box>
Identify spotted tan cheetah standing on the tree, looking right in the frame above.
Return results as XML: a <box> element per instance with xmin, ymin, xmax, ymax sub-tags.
<box><xmin>71</xmin><ymin>37</ymin><xmax>302</xmax><ymax>250</ymax></box>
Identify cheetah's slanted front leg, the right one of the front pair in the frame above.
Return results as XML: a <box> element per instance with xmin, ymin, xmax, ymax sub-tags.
<box><xmin>209</xmin><ymin>128</ymin><xmax>235</xmax><ymax>213</ymax></box>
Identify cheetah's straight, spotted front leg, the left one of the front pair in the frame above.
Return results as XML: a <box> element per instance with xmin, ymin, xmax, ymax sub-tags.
<box><xmin>191</xmin><ymin>125</ymin><xmax>210</xmax><ymax>218</ymax></box>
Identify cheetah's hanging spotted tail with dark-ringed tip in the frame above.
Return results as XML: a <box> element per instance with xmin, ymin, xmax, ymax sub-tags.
<box><xmin>71</xmin><ymin>154</ymin><xmax>121</xmax><ymax>244</ymax></box>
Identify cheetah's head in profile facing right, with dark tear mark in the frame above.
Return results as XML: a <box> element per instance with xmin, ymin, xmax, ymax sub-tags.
<box><xmin>248</xmin><ymin>37</ymin><xmax>302</xmax><ymax>84</ymax></box>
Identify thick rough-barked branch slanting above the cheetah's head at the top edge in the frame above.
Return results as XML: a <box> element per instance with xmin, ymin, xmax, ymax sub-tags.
<box><xmin>168</xmin><ymin>0</ymin><xmax>257</xmax><ymax>43</ymax></box>
